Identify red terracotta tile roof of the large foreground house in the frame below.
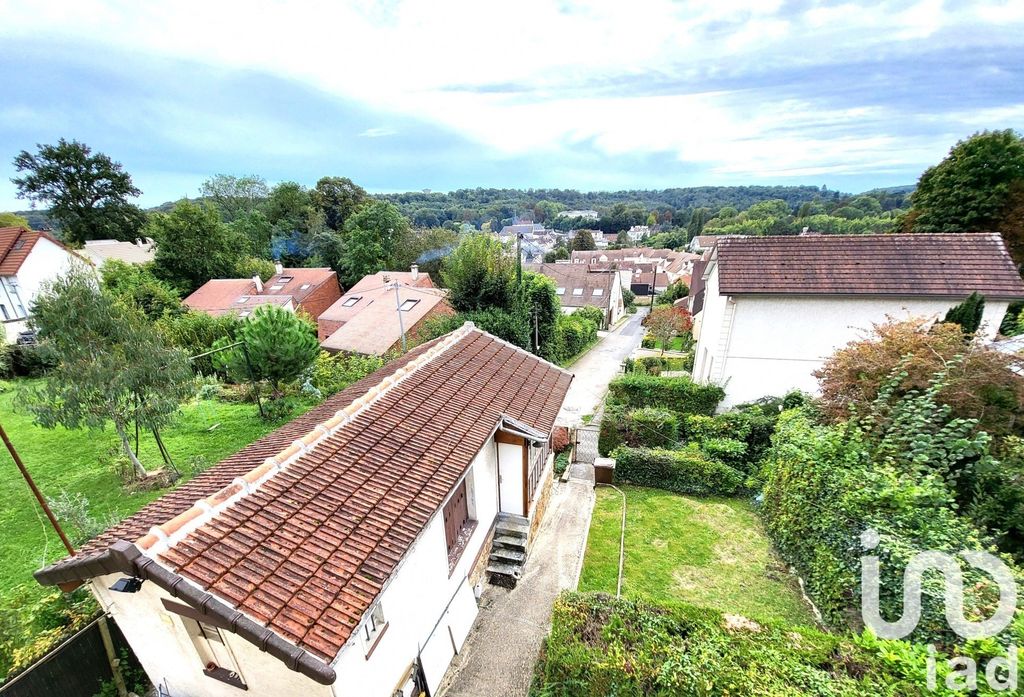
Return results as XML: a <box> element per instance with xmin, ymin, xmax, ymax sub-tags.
<box><xmin>37</xmin><ymin>325</ymin><xmax>571</xmax><ymax>660</ymax></box>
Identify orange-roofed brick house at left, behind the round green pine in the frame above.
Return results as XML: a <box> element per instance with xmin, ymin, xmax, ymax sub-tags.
<box><xmin>182</xmin><ymin>264</ymin><xmax>341</xmax><ymax>321</ymax></box>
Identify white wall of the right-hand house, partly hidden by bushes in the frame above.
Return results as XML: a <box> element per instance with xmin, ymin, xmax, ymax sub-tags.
<box><xmin>693</xmin><ymin>260</ymin><xmax>1008</xmax><ymax>408</ymax></box>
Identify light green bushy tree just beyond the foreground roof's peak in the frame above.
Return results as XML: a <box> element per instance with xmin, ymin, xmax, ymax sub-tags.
<box><xmin>441</xmin><ymin>233</ymin><xmax>515</xmax><ymax>311</ymax></box>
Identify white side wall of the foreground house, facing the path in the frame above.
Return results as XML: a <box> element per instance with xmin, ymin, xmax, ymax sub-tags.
<box><xmin>334</xmin><ymin>440</ymin><xmax>498</xmax><ymax>697</ymax></box>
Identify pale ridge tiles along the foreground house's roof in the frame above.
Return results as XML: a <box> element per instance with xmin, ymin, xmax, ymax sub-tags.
<box><xmin>135</xmin><ymin>321</ymin><xmax>479</xmax><ymax>558</ymax></box>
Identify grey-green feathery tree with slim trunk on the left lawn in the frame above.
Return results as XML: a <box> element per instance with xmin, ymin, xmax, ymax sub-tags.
<box><xmin>29</xmin><ymin>267</ymin><xmax>195</xmax><ymax>477</ymax></box>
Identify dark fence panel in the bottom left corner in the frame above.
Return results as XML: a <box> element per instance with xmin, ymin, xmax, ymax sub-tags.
<box><xmin>0</xmin><ymin>617</ymin><xmax>135</xmax><ymax>697</ymax></box>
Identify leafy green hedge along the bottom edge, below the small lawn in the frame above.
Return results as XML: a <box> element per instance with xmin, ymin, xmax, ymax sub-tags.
<box><xmin>530</xmin><ymin>593</ymin><xmax>954</xmax><ymax>697</ymax></box>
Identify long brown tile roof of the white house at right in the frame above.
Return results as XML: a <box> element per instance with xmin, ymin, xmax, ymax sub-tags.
<box><xmin>716</xmin><ymin>232</ymin><xmax>1024</xmax><ymax>298</ymax></box>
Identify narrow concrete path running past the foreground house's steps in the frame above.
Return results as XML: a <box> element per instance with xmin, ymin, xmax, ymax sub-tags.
<box><xmin>438</xmin><ymin>465</ymin><xmax>594</xmax><ymax>697</ymax></box>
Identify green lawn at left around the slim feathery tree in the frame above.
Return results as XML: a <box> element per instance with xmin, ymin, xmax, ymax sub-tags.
<box><xmin>0</xmin><ymin>383</ymin><xmax>309</xmax><ymax>608</ymax></box>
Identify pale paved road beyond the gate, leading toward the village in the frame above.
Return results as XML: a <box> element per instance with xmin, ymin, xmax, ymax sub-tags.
<box><xmin>556</xmin><ymin>308</ymin><xmax>647</xmax><ymax>426</ymax></box>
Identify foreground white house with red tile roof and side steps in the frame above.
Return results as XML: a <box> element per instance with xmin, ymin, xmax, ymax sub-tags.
<box><xmin>35</xmin><ymin>322</ymin><xmax>572</xmax><ymax>697</ymax></box>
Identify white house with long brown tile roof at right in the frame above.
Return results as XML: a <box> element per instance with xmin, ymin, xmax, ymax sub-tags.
<box><xmin>693</xmin><ymin>233</ymin><xmax>1024</xmax><ymax>407</ymax></box>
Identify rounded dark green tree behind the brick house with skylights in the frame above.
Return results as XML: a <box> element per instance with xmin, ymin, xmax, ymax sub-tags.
<box><xmin>340</xmin><ymin>201</ymin><xmax>409</xmax><ymax>286</ymax></box>
